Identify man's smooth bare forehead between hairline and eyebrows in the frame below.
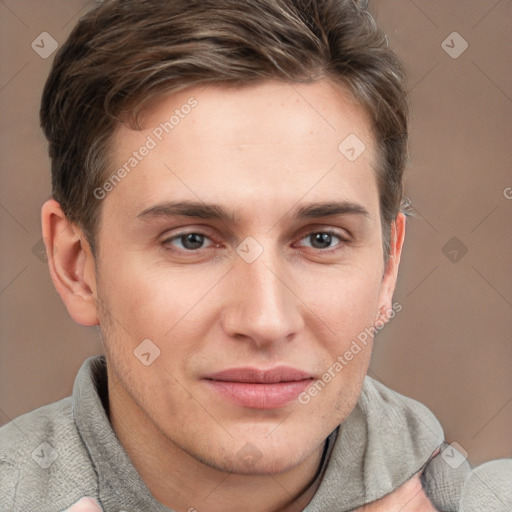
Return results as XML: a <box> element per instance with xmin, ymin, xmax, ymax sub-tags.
<box><xmin>105</xmin><ymin>81</ymin><xmax>376</xmax><ymax>222</ymax></box>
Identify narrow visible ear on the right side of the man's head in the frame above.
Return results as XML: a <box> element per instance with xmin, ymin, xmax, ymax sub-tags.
<box><xmin>376</xmin><ymin>213</ymin><xmax>406</xmax><ymax>323</ymax></box>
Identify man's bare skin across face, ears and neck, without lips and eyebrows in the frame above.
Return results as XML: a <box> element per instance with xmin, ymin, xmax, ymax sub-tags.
<box><xmin>42</xmin><ymin>80</ymin><xmax>405</xmax><ymax>512</ymax></box>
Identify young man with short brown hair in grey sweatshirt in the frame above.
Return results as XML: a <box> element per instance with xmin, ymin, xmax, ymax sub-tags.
<box><xmin>0</xmin><ymin>0</ymin><xmax>512</xmax><ymax>512</ymax></box>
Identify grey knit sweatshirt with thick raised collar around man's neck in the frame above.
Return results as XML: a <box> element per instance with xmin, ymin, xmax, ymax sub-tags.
<box><xmin>0</xmin><ymin>357</ymin><xmax>512</xmax><ymax>512</ymax></box>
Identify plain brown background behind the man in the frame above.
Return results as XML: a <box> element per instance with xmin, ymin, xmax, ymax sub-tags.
<box><xmin>0</xmin><ymin>0</ymin><xmax>512</xmax><ymax>463</ymax></box>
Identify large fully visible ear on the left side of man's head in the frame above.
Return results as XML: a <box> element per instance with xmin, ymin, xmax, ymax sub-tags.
<box><xmin>41</xmin><ymin>199</ymin><xmax>98</xmax><ymax>325</ymax></box>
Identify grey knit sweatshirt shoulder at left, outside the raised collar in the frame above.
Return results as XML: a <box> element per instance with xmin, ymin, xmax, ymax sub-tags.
<box><xmin>0</xmin><ymin>397</ymin><xmax>97</xmax><ymax>512</ymax></box>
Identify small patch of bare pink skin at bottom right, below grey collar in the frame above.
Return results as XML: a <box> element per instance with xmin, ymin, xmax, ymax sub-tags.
<box><xmin>355</xmin><ymin>473</ymin><xmax>437</xmax><ymax>512</ymax></box>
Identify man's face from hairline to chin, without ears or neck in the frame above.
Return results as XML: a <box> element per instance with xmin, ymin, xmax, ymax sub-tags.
<box><xmin>89</xmin><ymin>81</ymin><xmax>400</xmax><ymax>473</ymax></box>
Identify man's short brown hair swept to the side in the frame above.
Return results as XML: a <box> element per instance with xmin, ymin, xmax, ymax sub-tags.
<box><xmin>40</xmin><ymin>0</ymin><xmax>408</xmax><ymax>259</ymax></box>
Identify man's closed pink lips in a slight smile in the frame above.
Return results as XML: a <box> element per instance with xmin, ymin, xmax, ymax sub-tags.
<box><xmin>204</xmin><ymin>366</ymin><xmax>314</xmax><ymax>409</ymax></box>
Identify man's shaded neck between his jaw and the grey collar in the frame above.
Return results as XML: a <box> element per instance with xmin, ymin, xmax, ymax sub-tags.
<box><xmin>108</xmin><ymin>379</ymin><xmax>325</xmax><ymax>512</ymax></box>
